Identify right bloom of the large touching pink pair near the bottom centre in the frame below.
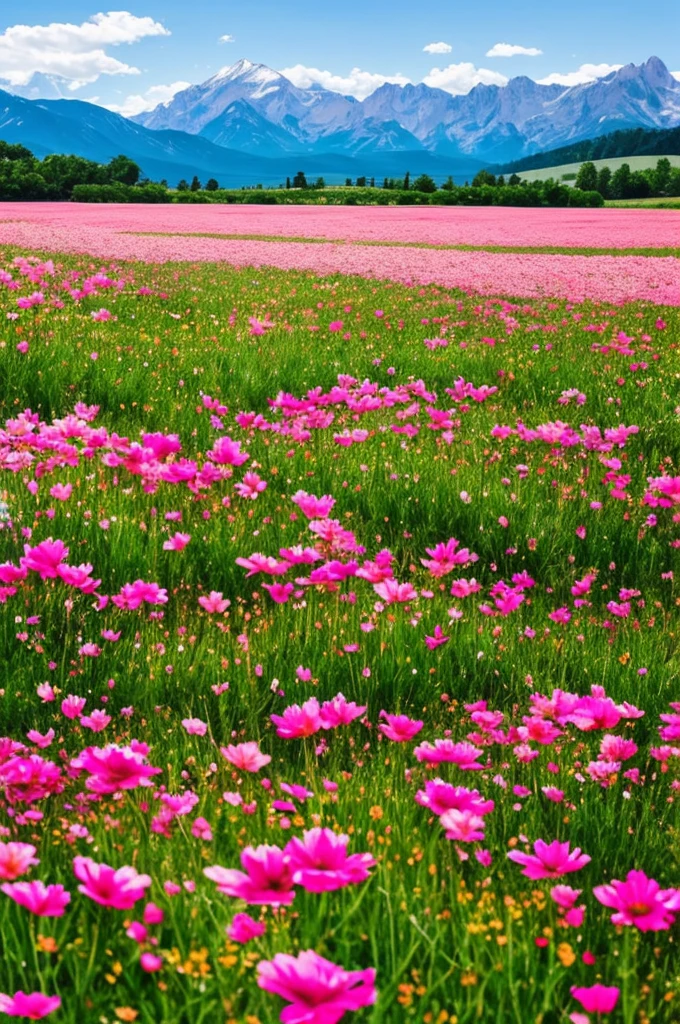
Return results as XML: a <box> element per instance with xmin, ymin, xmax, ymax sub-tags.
<box><xmin>284</xmin><ymin>828</ymin><xmax>376</xmax><ymax>893</ymax></box>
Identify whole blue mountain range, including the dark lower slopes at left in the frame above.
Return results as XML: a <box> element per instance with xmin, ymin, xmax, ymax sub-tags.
<box><xmin>0</xmin><ymin>56</ymin><xmax>680</xmax><ymax>186</ymax></box>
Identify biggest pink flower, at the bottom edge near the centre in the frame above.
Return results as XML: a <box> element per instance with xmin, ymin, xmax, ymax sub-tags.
<box><xmin>257</xmin><ymin>949</ymin><xmax>377</xmax><ymax>1024</ymax></box>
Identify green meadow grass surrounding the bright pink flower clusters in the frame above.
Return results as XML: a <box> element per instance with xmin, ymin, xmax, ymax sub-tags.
<box><xmin>0</xmin><ymin>250</ymin><xmax>680</xmax><ymax>1024</ymax></box>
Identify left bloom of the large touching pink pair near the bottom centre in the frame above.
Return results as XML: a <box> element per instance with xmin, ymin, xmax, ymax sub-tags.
<box><xmin>203</xmin><ymin>846</ymin><xmax>295</xmax><ymax>906</ymax></box>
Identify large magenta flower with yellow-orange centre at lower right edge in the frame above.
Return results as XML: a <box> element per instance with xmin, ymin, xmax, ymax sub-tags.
<box><xmin>593</xmin><ymin>870</ymin><xmax>680</xmax><ymax>932</ymax></box>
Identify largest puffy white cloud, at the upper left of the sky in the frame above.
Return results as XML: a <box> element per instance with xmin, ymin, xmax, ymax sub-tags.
<box><xmin>0</xmin><ymin>10</ymin><xmax>170</xmax><ymax>87</ymax></box>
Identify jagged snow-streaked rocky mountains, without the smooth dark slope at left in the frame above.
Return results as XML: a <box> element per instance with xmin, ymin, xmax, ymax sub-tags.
<box><xmin>134</xmin><ymin>56</ymin><xmax>680</xmax><ymax>162</ymax></box>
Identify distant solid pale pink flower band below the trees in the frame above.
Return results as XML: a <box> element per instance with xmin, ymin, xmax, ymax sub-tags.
<box><xmin>0</xmin><ymin>203</ymin><xmax>680</xmax><ymax>305</ymax></box>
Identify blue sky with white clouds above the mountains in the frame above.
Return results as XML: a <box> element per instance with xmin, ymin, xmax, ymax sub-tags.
<box><xmin>0</xmin><ymin>0</ymin><xmax>680</xmax><ymax>114</ymax></box>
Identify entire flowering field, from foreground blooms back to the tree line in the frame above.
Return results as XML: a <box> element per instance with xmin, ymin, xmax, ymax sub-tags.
<box><xmin>0</xmin><ymin>206</ymin><xmax>680</xmax><ymax>1024</ymax></box>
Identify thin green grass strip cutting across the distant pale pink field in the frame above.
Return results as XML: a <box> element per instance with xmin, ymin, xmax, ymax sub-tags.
<box><xmin>130</xmin><ymin>231</ymin><xmax>680</xmax><ymax>257</ymax></box>
